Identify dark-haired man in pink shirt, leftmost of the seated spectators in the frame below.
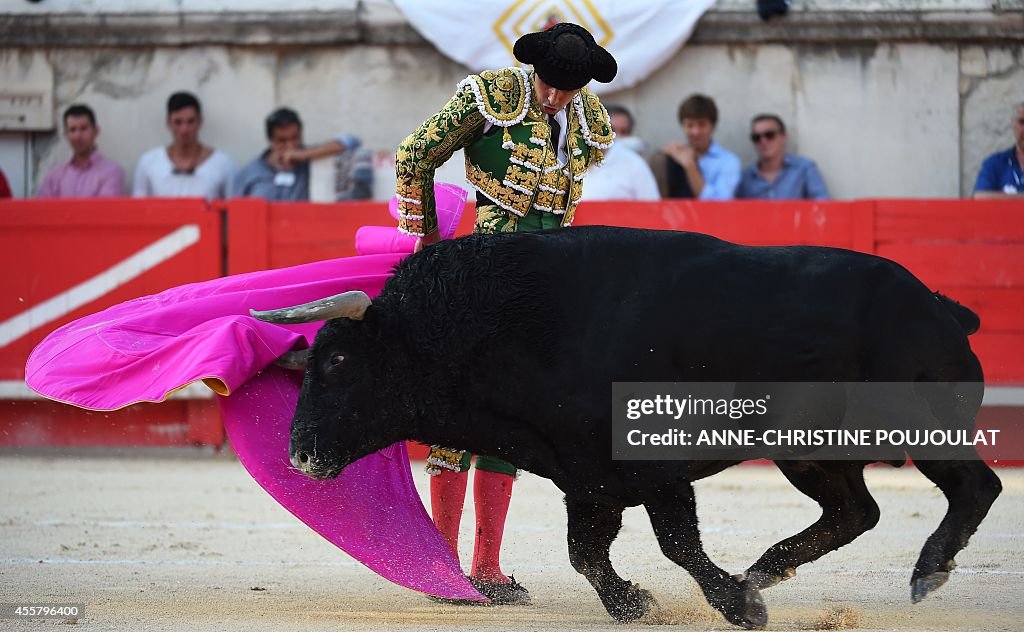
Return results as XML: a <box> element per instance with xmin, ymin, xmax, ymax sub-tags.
<box><xmin>36</xmin><ymin>104</ymin><xmax>125</xmax><ymax>198</ymax></box>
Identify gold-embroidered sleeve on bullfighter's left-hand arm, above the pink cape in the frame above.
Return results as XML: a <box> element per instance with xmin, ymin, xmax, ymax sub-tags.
<box><xmin>395</xmin><ymin>81</ymin><xmax>484</xmax><ymax>237</ymax></box>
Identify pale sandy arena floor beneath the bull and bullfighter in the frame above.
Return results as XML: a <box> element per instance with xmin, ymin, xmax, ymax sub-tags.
<box><xmin>0</xmin><ymin>453</ymin><xmax>1024</xmax><ymax>632</ymax></box>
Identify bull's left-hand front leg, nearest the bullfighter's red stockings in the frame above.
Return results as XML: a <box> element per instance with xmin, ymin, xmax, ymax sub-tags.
<box><xmin>565</xmin><ymin>496</ymin><xmax>654</xmax><ymax>622</ymax></box>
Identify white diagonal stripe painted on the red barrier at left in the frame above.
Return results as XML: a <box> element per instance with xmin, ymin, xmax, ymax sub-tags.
<box><xmin>0</xmin><ymin>224</ymin><xmax>200</xmax><ymax>347</ymax></box>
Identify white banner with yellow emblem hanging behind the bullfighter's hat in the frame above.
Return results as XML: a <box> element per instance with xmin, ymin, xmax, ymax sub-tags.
<box><xmin>394</xmin><ymin>0</ymin><xmax>715</xmax><ymax>93</ymax></box>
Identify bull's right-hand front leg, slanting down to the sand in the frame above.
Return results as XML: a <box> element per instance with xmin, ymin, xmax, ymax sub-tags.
<box><xmin>644</xmin><ymin>482</ymin><xmax>768</xmax><ymax>628</ymax></box>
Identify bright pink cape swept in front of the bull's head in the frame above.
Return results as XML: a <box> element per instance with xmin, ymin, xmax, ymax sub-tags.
<box><xmin>26</xmin><ymin>183</ymin><xmax>485</xmax><ymax>600</ymax></box>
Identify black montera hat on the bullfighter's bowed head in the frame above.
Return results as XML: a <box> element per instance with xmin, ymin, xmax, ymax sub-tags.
<box><xmin>512</xmin><ymin>22</ymin><xmax>618</xmax><ymax>90</ymax></box>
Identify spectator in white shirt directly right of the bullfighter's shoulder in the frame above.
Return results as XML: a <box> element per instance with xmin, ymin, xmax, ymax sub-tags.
<box><xmin>582</xmin><ymin>106</ymin><xmax>660</xmax><ymax>200</ymax></box>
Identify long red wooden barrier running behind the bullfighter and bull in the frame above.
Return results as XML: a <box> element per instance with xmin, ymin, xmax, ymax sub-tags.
<box><xmin>0</xmin><ymin>199</ymin><xmax>1024</xmax><ymax>445</ymax></box>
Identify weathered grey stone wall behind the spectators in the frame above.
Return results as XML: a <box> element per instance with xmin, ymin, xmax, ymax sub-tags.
<box><xmin>0</xmin><ymin>0</ymin><xmax>1024</xmax><ymax>198</ymax></box>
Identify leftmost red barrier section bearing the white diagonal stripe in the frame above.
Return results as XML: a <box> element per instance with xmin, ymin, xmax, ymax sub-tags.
<box><xmin>0</xmin><ymin>199</ymin><xmax>223</xmax><ymax>446</ymax></box>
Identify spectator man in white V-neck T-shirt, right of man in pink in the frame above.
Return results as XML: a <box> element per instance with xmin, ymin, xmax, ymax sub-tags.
<box><xmin>132</xmin><ymin>92</ymin><xmax>234</xmax><ymax>198</ymax></box>
